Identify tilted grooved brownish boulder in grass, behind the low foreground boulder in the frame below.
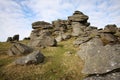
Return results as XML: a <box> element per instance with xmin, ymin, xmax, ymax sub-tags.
<box><xmin>7</xmin><ymin>43</ymin><xmax>33</xmax><ymax>56</ymax></box>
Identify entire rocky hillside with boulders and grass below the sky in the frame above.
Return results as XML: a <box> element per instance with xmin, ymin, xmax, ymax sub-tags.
<box><xmin>0</xmin><ymin>11</ymin><xmax>120</xmax><ymax>80</ymax></box>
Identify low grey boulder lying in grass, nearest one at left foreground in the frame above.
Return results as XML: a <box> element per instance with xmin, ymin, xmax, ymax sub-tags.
<box><xmin>14</xmin><ymin>51</ymin><xmax>45</xmax><ymax>65</ymax></box>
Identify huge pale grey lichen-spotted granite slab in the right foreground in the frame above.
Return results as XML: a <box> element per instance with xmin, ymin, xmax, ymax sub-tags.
<box><xmin>78</xmin><ymin>38</ymin><xmax>120</xmax><ymax>74</ymax></box>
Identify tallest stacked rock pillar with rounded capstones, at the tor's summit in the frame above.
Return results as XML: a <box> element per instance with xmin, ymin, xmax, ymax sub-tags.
<box><xmin>68</xmin><ymin>11</ymin><xmax>90</xmax><ymax>36</ymax></box>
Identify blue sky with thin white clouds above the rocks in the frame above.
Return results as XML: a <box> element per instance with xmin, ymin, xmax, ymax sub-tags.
<box><xmin>0</xmin><ymin>0</ymin><xmax>120</xmax><ymax>41</ymax></box>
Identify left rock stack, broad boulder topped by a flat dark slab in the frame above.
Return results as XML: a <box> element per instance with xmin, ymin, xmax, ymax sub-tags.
<box><xmin>29</xmin><ymin>21</ymin><xmax>57</xmax><ymax>47</ymax></box>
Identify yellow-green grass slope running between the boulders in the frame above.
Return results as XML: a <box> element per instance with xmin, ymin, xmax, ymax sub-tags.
<box><xmin>0</xmin><ymin>38</ymin><xmax>85</xmax><ymax>80</ymax></box>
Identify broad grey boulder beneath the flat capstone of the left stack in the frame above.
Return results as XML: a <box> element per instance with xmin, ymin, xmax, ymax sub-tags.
<box><xmin>29</xmin><ymin>30</ymin><xmax>57</xmax><ymax>47</ymax></box>
